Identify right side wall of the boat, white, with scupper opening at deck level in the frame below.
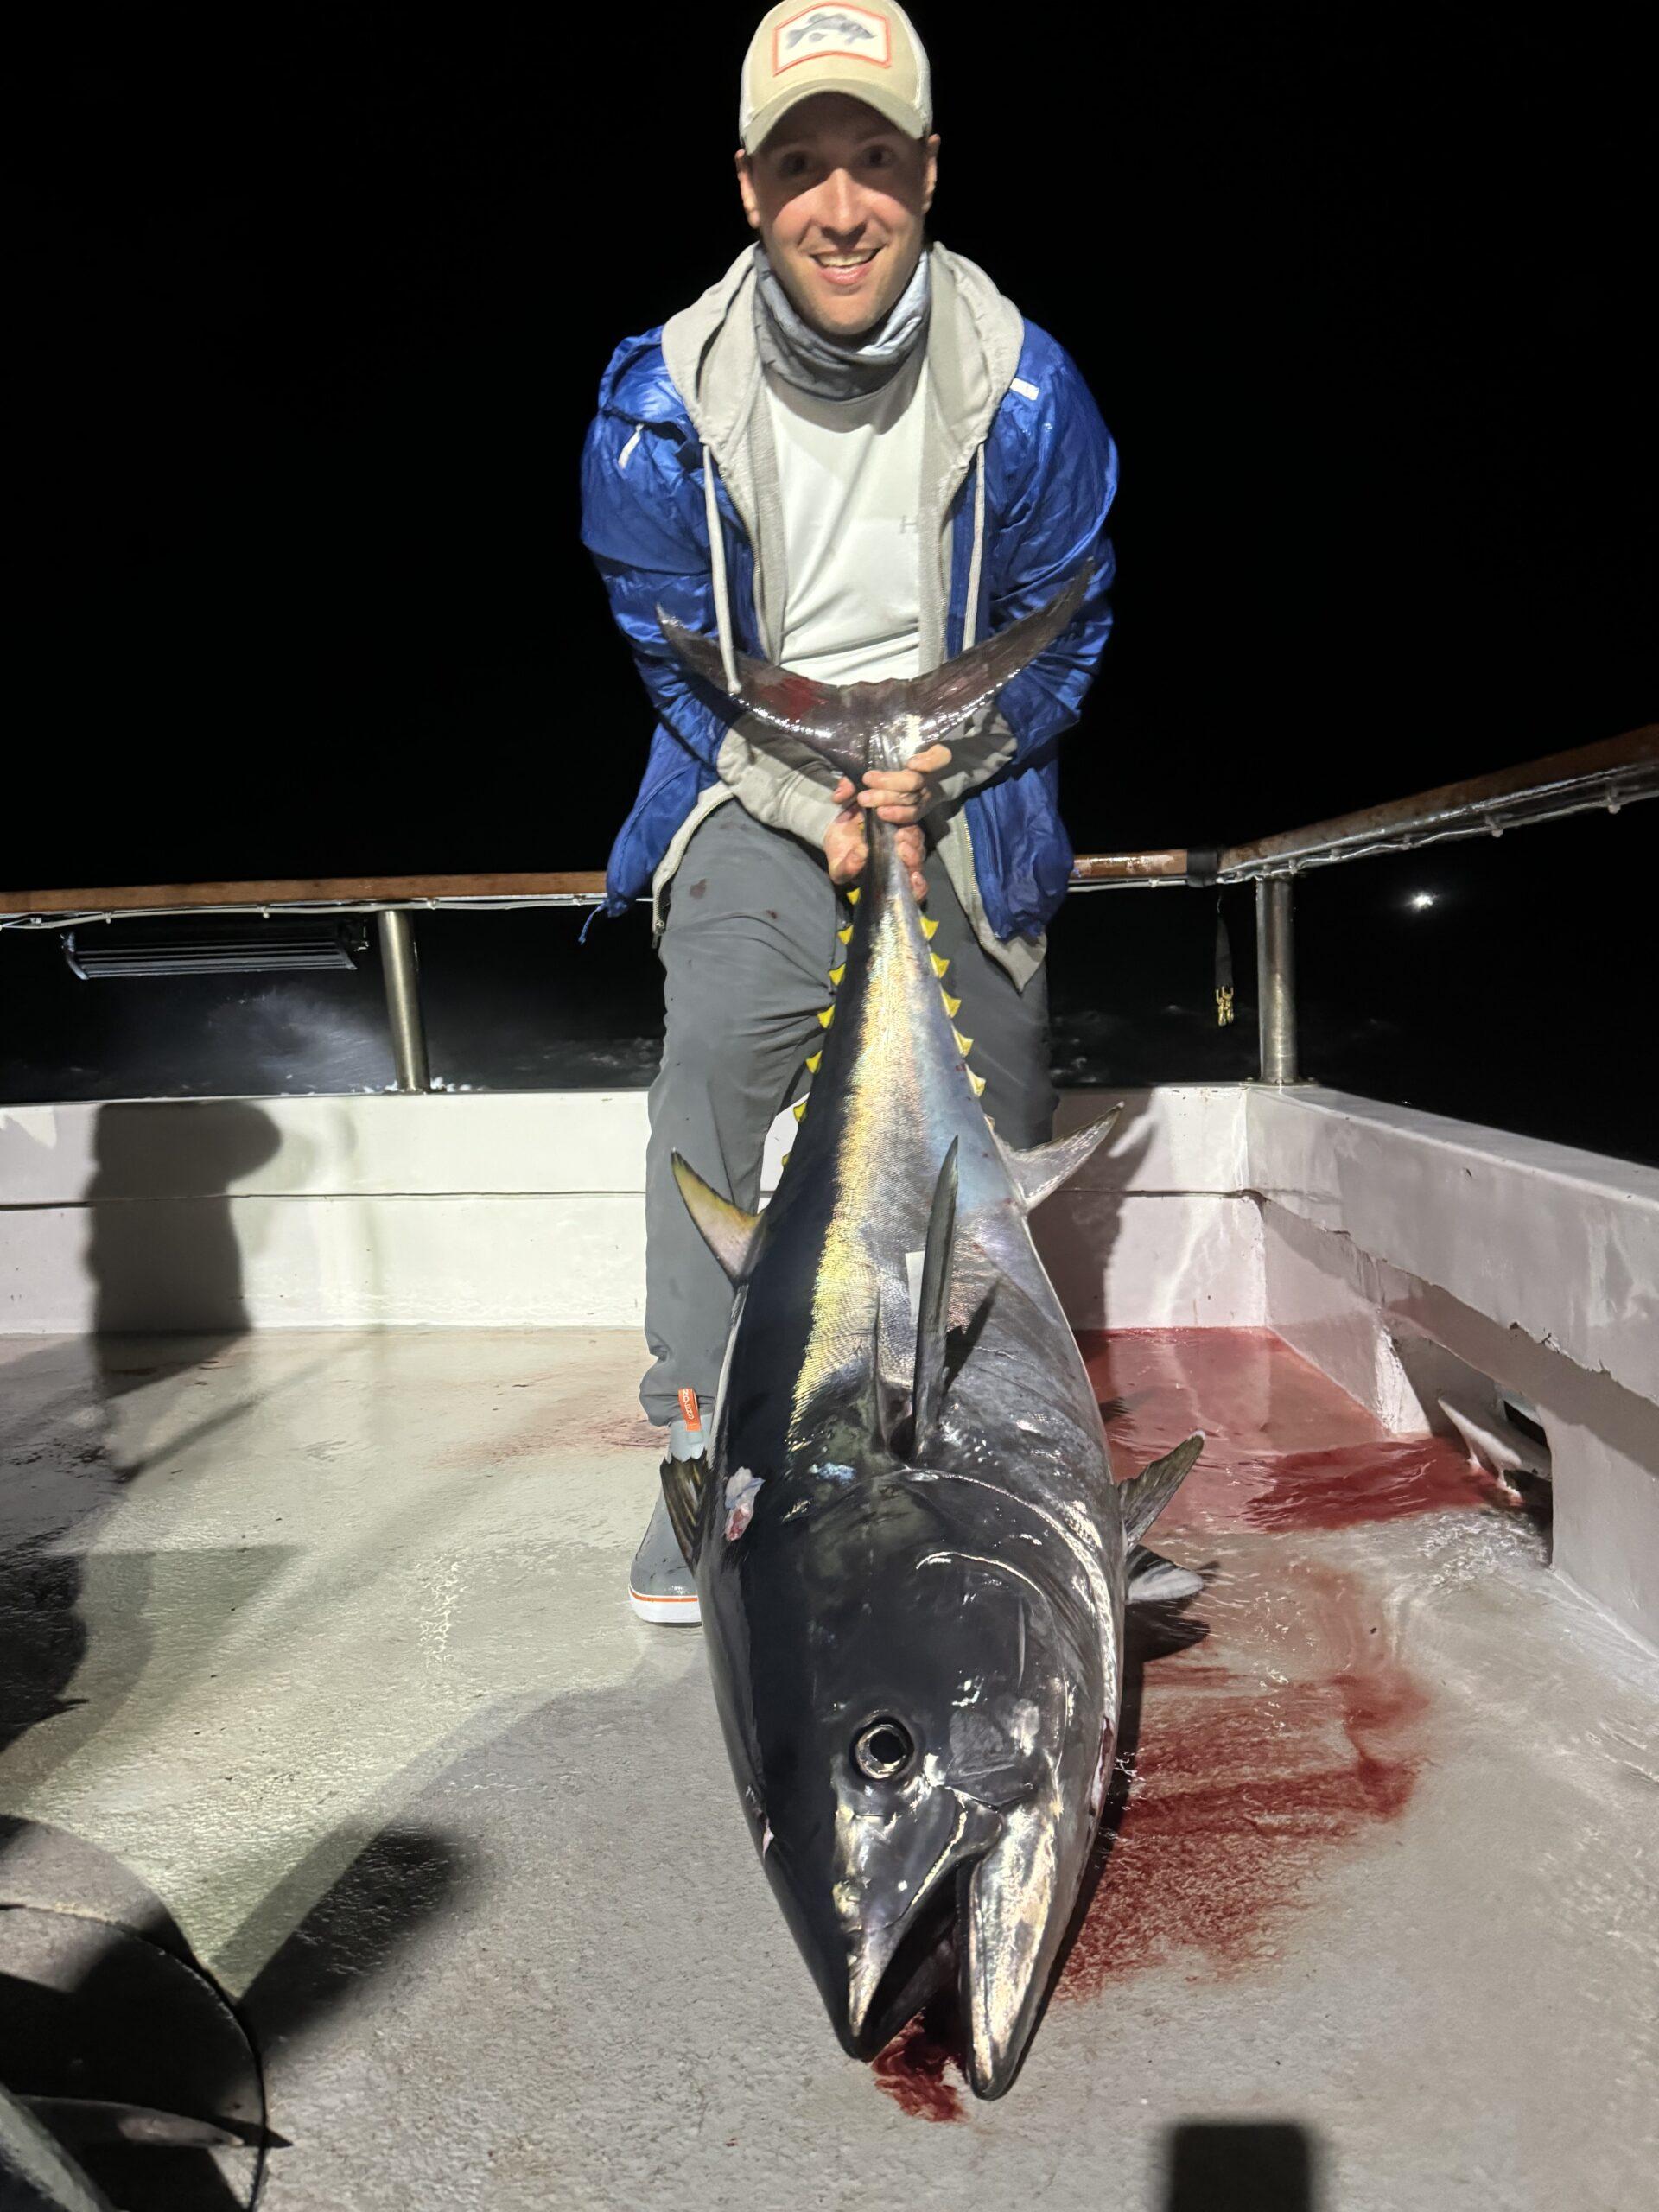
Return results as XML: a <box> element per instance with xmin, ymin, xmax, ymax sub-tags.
<box><xmin>1245</xmin><ymin>1089</ymin><xmax>1659</xmax><ymax>1643</ymax></box>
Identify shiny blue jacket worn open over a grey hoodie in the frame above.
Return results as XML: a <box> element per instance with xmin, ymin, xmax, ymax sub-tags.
<box><xmin>582</xmin><ymin>245</ymin><xmax>1117</xmax><ymax>940</ymax></box>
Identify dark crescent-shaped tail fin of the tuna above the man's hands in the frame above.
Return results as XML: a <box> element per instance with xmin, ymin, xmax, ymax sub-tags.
<box><xmin>657</xmin><ymin>562</ymin><xmax>1095</xmax><ymax>783</ymax></box>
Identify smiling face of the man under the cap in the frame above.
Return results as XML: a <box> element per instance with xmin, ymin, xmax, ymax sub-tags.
<box><xmin>736</xmin><ymin>93</ymin><xmax>938</xmax><ymax>339</ymax></box>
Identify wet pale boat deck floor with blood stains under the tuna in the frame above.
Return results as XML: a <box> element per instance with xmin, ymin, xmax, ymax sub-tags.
<box><xmin>0</xmin><ymin>1332</ymin><xmax>1659</xmax><ymax>2212</ymax></box>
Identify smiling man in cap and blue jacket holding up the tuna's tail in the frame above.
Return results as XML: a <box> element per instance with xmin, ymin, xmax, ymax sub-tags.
<box><xmin>582</xmin><ymin>0</ymin><xmax>1117</xmax><ymax>1621</ymax></box>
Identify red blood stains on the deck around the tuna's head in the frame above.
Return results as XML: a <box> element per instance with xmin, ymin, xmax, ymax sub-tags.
<box><xmin>874</xmin><ymin>1330</ymin><xmax>1516</xmax><ymax>2119</ymax></box>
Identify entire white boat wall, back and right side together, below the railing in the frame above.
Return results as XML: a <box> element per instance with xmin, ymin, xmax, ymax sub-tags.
<box><xmin>0</xmin><ymin>1086</ymin><xmax>1659</xmax><ymax>1642</ymax></box>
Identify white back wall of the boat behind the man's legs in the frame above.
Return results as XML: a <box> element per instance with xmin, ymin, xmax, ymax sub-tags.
<box><xmin>0</xmin><ymin>1089</ymin><xmax>1263</xmax><ymax>1334</ymax></box>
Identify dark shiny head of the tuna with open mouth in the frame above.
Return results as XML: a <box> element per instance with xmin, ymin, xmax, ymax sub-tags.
<box><xmin>716</xmin><ymin>1469</ymin><xmax>1115</xmax><ymax>2097</ymax></box>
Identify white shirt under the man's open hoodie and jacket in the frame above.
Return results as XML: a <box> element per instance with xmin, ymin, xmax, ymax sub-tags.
<box><xmin>766</xmin><ymin>347</ymin><xmax>927</xmax><ymax>683</ymax></box>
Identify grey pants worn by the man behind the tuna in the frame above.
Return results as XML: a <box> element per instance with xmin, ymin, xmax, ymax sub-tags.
<box><xmin>639</xmin><ymin>798</ymin><xmax>1055</xmax><ymax>1427</ymax></box>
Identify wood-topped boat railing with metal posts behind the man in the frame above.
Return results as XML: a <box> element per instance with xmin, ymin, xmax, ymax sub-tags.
<box><xmin>0</xmin><ymin>723</ymin><xmax>1659</xmax><ymax>1090</ymax></box>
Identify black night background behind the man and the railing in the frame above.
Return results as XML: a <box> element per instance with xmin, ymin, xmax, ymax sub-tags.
<box><xmin>0</xmin><ymin>0</ymin><xmax>1659</xmax><ymax>1159</ymax></box>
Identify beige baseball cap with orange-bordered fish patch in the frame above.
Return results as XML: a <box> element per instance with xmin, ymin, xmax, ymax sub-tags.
<box><xmin>736</xmin><ymin>0</ymin><xmax>933</xmax><ymax>153</ymax></box>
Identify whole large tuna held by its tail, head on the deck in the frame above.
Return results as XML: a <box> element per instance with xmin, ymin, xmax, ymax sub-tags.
<box><xmin>659</xmin><ymin>575</ymin><xmax>1201</xmax><ymax>2097</ymax></box>
